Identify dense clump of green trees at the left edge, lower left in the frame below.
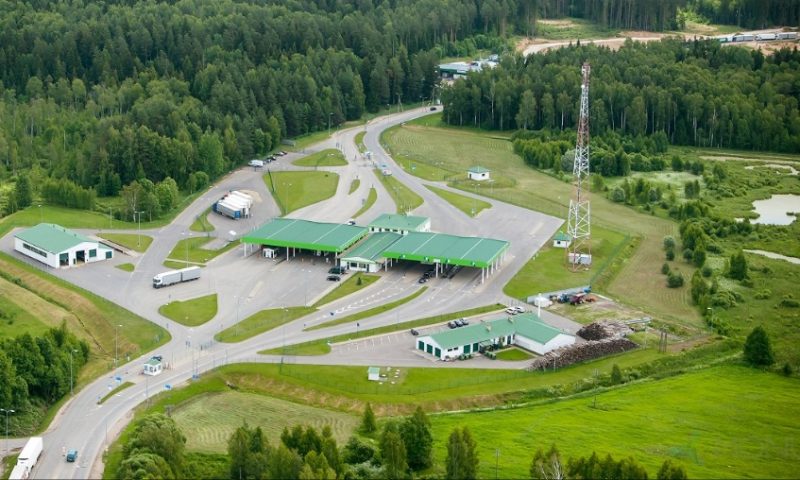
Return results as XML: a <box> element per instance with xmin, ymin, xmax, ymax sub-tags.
<box><xmin>0</xmin><ymin>318</ymin><xmax>89</xmax><ymax>435</ymax></box>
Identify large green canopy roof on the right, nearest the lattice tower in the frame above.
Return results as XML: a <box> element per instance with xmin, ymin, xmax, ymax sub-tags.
<box><xmin>383</xmin><ymin>232</ymin><xmax>509</xmax><ymax>268</ymax></box>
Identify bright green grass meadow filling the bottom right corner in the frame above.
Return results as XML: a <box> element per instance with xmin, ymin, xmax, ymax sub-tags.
<box><xmin>431</xmin><ymin>366</ymin><xmax>800</xmax><ymax>478</ymax></box>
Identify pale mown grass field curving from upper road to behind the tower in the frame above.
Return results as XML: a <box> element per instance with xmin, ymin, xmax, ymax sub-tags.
<box><xmin>382</xmin><ymin>119</ymin><xmax>701</xmax><ymax>325</ymax></box>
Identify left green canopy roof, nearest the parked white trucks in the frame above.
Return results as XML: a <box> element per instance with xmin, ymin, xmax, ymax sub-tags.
<box><xmin>242</xmin><ymin>218</ymin><xmax>368</xmax><ymax>253</ymax></box>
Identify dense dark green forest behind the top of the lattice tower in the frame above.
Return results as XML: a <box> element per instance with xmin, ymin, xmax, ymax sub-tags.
<box><xmin>442</xmin><ymin>39</ymin><xmax>800</xmax><ymax>152</ymax></box>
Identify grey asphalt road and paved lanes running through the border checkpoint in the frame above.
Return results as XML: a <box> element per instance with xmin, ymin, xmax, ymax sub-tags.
<box><xmin>0</xmin><ymin>109</ymin><xmax>563</xmax><ymax>478</ymax></box>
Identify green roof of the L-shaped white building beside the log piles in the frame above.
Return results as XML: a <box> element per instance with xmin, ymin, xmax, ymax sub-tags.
<box><xmin>430</xmin><ymin>313</ymin><xmax>568</xmax><ymax>349</ymax></box>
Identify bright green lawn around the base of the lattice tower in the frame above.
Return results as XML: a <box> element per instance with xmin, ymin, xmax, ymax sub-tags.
<box><xmin>503</xmin><ymin>227</ymin><xmax>626</xmax><ymax>299</ymax></box>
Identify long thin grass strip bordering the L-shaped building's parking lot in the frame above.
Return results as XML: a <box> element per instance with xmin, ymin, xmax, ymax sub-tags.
<box><xmin>258</xmin><ymin>303</ymin><xmax>506</xmax><ymax>355</ymax></box>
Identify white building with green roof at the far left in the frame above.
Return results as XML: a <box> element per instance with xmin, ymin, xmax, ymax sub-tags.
<box><xmin>14</xmin><ymin>223</ymin><xmax>114</xmax><ymax>268</ymax></box>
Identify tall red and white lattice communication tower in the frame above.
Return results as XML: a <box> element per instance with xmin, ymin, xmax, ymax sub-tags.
<box><xmin>567</xmin><ymin>63</ymin><xmax>592</xmax><ymax>271</ymax></box>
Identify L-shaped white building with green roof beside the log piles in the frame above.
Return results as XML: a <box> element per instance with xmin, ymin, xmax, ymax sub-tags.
<box><xmin>416</xmin><ymin>313</ymin><xmax>575</xmax><ymax>360</ymax></box>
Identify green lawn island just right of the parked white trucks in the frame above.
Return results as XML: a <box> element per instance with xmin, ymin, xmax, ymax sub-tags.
<box><xmin>264</xmin><ymin>171</ymin><xmax>339</xmax><ymax>215</ymax></box>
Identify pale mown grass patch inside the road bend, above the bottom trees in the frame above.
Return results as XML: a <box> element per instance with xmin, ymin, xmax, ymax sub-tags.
<box><xmin>172</xmin><ymin>391</ymin><xmax>360</xmax><ymax>453</ymax></box>
